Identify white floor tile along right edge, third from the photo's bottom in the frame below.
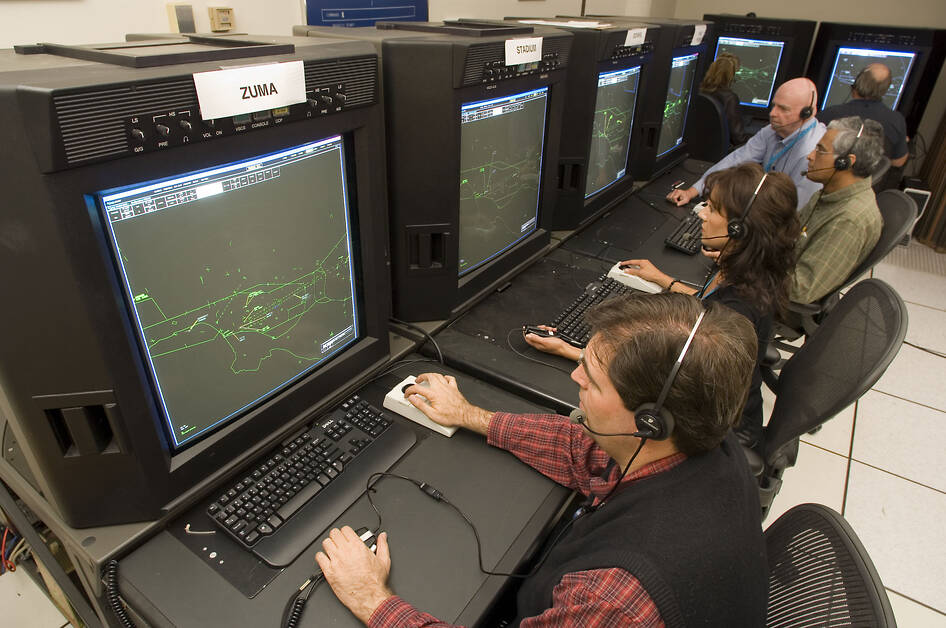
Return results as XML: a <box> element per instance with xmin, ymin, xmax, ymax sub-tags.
<box><xmin>853</xmin><ymin>390</ymin><xmax>946</xmax><ymax>492</ymax></box>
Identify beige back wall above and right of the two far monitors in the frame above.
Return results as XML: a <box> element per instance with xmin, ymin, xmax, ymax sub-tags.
<box><xmin>674</xmin><ymin>0</ymin><xmax>946</xmax><ymax>159</ymax></box>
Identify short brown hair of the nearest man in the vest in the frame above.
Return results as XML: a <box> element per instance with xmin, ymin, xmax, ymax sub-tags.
<box><xmin>586</xmin><ymin>292</ymin><xmax>757</xmax><ymax>455</ymax></box>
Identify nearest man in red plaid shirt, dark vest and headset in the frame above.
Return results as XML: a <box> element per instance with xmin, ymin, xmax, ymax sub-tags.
<box><xmin>316</xmin><ymin>294</ymin><xmax>767</xmax><ymax>628</ymax></box>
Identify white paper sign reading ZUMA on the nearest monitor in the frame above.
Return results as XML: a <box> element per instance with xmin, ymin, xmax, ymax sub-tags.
<box><xmin>194</xmin><ymin>61</ymin><xmax>305</xmax><ymax>120</ymax></box>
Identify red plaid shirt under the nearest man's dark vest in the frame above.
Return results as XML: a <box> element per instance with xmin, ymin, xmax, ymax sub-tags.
<box><xmin>368</xmin><ymin>412</ymin><xmax>686</xmax><ymax>628</ymax></box>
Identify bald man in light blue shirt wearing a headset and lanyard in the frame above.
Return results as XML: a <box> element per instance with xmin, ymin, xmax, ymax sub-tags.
<box><xmin>667</xmin><ymin>78</ymin><xmax>825</xmax><ymax>208</ymax></box>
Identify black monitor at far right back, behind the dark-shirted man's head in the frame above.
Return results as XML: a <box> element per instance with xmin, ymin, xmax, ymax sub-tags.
<box><xmin>806</xmin><ymin>22</ymin><xmax>946</xmax><ymax>136</ymax></box>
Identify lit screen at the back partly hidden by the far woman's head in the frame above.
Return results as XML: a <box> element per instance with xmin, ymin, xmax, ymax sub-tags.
<box><xmin>716</xmin><ymin>37</ymin><xmax>785</xmax><ymax>109</ymax></box>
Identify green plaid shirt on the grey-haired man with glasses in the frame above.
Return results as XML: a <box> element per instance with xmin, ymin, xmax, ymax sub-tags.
<box><xmin>791</xmin><ymin>178</ymin><xmax>883</xmax><ymax>303</ymax></box>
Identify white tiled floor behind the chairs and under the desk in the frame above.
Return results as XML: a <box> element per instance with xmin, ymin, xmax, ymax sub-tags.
<box><xmin>0</xmin><ymin>243</ymin><xmax>946</xmax><ymax>628</ymax></box>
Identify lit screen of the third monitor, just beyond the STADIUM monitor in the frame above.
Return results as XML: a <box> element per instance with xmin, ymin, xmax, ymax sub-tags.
<box><xmin>585</xmin><ymin>65</ymin><xmax>641</xmax><ymax>198</ymax></box>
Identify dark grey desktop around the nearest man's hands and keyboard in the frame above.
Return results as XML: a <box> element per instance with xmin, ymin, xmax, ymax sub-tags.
<box><xmin>120</xmin><ymin>356</ymin><xmax>570</xmax><ymax>627</ymax></box>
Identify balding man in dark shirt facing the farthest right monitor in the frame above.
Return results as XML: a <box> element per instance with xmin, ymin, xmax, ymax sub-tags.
<box><xmin>818</xmin><ymin>63</ymin><xmax>910</xmax><ymax>168</ymax></box>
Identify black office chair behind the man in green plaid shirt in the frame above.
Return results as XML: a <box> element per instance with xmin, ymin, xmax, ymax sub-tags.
<box><xmin>763</xmin><ymin>190</ymin><xmax>916</xmax><ymax>364</ymax></box>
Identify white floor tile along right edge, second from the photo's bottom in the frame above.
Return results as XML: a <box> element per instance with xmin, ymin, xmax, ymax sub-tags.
<box><xmin>844</xmin><ymin>462</ymin><xmax>946</xmax><ymax>612</ymax></box>
